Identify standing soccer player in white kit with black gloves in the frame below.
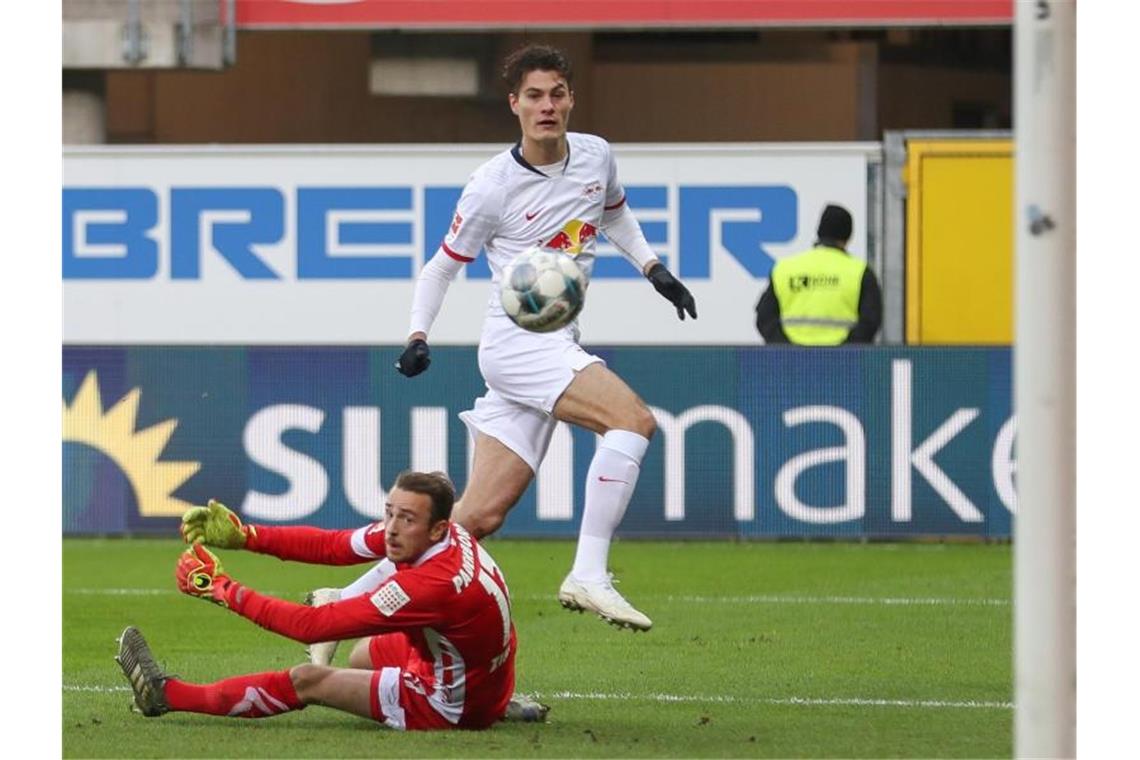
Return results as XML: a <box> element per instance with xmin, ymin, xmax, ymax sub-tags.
<box><xmin>318</xmin><ymin>46</ymin><xmax>697</xmax><ymax>642</ymax></box>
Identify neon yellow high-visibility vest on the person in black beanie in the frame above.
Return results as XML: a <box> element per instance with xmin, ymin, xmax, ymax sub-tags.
<box><xmin>771</xmin><ymin>245</ymin><xmax>866</xmax><ymax>345</ymax></box>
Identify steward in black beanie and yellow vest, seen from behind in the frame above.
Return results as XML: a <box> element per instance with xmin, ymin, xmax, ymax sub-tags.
<box><xmin>756</xmin><ymin>205</ymin><xmax>882</xmax><ymax>345</ymax></box>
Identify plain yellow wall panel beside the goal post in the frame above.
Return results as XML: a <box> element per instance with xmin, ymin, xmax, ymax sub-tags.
<box><xmin>906</xmin><ymin>139</ymin><xmax>1013</xmax><ymax>344</ymax></box>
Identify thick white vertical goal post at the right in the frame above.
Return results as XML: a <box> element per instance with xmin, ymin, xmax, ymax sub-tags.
<box><xmin>1013</xmin><ymin>0</ymin><xmax>1076</xmax><ymax>758</ymax></box>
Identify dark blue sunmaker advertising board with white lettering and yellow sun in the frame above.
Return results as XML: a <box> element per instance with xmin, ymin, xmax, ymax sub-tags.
<box><xmin>63</xmin><ymin>345</ymin><xmax>1017</xmax><ymax>538</ymax></box>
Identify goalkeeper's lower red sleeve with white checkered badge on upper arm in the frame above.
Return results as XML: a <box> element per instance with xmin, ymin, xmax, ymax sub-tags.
<box><xmin>229</xmin><ymin>569</ymin><xmax>444</xmax><ymax>644</ymax></box>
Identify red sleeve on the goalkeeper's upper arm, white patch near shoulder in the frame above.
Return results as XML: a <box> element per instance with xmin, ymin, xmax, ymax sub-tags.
<box><xmin>245</xmin><ymin>523</ymin><xmax>385</xmax><ymax>565</ymax></box>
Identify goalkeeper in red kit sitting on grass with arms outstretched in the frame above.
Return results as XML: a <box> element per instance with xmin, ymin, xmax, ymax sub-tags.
<box><xmin>116</xmin><ymin>472</ymin><xmax>516</xmax><ymax>730</ymax></box>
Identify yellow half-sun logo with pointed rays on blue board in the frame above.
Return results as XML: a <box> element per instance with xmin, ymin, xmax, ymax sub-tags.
<box><xmin>63</xmin><ymin>369</ymin><xmax>202</xmax><ymax>517</ymax></box>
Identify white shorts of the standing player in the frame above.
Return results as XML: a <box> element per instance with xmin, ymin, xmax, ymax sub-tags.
<box><xmin>459</xmin><ymin>317</ymin><xmax>605</xmax><ymax>473</ymax></box>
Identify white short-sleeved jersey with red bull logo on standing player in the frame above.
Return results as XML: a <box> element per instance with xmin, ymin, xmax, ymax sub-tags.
<box><xmin>441</xmin><ymin>132</ymin><xmax>626</xmax><ymax>317</ymax></box>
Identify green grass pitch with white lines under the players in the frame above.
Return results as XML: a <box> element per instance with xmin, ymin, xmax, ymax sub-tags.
<box><xmin>63</xmin><ymin>539</ymin><xmax>1013</xmax><ymax>758</ymax></box>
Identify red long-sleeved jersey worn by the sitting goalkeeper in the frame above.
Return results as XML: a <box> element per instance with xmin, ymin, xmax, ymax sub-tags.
<box><xmin>230</xmin><ymin>523</ymin><xmax>518</xmax><ymax>727</ymax></box>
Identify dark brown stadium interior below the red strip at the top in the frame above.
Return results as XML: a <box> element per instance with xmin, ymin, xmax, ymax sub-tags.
<box><xmin>64</xmin><ymin>27</ymin><xmax>1011</xmax><ymax>144</ymax></box>
